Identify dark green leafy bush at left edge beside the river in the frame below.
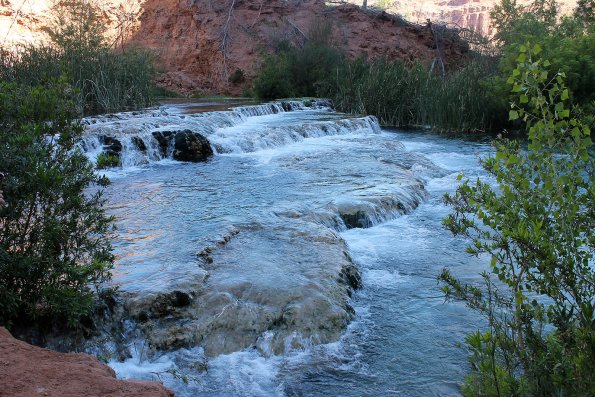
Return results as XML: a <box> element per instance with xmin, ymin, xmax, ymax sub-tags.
<box><xmin>0</xmin><ymin>80</ymin><xmax>113</xmax><ymax>327</ymax></box>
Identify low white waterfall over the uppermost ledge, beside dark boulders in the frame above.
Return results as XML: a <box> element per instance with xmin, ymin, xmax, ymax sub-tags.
<box><xmin>79</xmin><ymin>101</ymin><xmax>380</xmax><ymax>168</ymax></box>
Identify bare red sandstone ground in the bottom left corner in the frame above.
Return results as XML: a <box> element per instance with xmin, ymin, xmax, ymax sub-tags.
<box><xmin>0</xmin><ymin>327</ymin><xmax>174</xmax><ymax>397</ymax></box>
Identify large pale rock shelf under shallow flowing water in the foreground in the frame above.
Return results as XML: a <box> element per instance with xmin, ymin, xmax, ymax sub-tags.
<box><xmin>123</xmin><ymin>221</ymin><xmax>361</xmax><ymax>357</ymax></box>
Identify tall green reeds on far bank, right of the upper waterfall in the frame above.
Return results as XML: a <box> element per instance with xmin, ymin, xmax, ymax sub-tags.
<box><xmin>321</xmin><ymin>59</ymin><xmax>503</xmax><ymax>132</ymax></box>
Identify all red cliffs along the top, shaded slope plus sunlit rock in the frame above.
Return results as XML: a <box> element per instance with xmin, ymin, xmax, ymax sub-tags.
<box><xmin>0</xmin><ymin>0</ymin><xmax>576</xmax><ymax>95</ymax></box>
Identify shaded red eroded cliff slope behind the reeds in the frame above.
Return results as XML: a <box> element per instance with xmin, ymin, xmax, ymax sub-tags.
<box><xmin>133</xmin><ymin>0</ymin><xmax>468</xmax><ymax>95</ymax></box>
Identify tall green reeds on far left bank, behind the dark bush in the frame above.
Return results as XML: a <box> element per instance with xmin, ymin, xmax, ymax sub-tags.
<box><xmin>0</xmin><ymin>45</ymin><xmax>155</xmax><ymax>114</ymax></box>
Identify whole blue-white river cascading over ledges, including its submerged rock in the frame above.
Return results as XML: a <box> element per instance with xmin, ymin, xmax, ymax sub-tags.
<box><xmin>82</xmin><ymin>101</ymin><xmax>490</xmax><ymax>396</ymax></box>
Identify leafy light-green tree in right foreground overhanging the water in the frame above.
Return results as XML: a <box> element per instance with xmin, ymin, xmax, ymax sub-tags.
<box><xmin>440</xmin><ymin>44</ymin><xmax>595</xmax><ymax>396</ymax></box>
